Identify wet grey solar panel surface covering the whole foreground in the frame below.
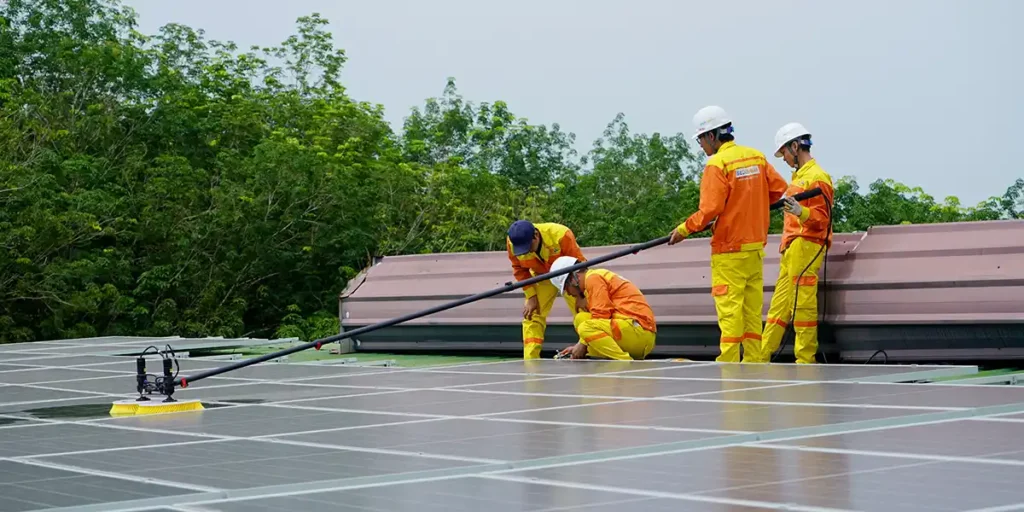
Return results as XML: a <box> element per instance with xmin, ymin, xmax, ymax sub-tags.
<box><xmin>0</xmin><ymin>338</ymin><xmax>1024</xmax><ymax>512</ymax></box>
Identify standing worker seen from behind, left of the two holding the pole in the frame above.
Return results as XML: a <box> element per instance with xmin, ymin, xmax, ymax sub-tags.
<box><xmin>669</xmin><ymin>105</ymin><xmax>786</xmax><ymax>362</ymax></box>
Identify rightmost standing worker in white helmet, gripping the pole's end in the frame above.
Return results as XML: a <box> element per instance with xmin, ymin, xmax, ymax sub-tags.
<box><xmin>761</xmin><ymin>123</ymin><xmax>834</xmax><ymax>364</ymax></box>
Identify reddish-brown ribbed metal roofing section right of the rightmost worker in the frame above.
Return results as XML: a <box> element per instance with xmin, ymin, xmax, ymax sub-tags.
<box><xmin>826</xmin><ymin>221</ymin><xmax>1024</xmax><ymax>325</ymax></box>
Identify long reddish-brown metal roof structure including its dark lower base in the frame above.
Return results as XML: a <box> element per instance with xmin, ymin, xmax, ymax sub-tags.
<box><xmin>339</xmin><ymin>220</ymin><xmax>1024</xmax><ymax>359</ymax></box>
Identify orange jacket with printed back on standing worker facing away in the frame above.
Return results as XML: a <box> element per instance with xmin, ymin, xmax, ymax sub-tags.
<box><xmin>678</xmin><ymin>140</ymin><xmax>786</xmax><ymax>254</ymax></box>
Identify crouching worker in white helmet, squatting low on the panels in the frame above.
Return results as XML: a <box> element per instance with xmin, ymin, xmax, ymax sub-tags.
<box><xmin>551</xmin><ymin>256</ymin><xmax>656</xmax><ymax>360</ymax></box>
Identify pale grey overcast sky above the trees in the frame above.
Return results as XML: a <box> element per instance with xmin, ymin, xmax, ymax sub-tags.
<box><xmin>126</xmin><ymin>0</ymin><xmax>1024</xmax><ymax>205</ymax></box>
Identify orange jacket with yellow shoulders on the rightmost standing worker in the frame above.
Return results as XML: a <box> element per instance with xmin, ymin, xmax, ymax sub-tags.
<box><xmin>779</xmin><ymin>160</ymin><xmax>835</xmax><ymax>252</ymax></box>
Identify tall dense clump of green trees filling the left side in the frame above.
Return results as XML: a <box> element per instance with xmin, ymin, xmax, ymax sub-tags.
<box><xmin>0</xmin><ymin>0</ymin><xmax>410</xmax><ymax>340</ymax></box>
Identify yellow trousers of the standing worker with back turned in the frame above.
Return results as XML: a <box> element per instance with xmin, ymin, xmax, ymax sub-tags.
<box><xmin>711</xmin><ymin>249</ymin><xmax>765</xmax><ymax>362</ymax></box>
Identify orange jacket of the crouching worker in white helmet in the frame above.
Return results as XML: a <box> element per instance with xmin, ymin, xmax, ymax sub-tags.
<box><xmin>584</xmin><ymin>268</ymin><xmax>656</xmax><ymax>333</ymax></box>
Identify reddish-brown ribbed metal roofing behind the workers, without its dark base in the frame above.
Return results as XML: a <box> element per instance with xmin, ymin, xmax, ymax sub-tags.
<box><xmin>340</xmin><ymin>220</ymin><xmax>1024</xmax><ymax>327</ymax></box>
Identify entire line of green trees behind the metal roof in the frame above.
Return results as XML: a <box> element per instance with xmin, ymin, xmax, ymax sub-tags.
<box><xmin>0</xmin><ymin>0</ymin><xmax>1024</xmax><ymax>342</ymax></box>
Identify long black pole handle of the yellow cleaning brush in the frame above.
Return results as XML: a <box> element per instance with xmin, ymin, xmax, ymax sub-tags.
<box><xmin>174</xmin><ymin>188</ymin><xmax>821</xmax><ymax>387</ymax></box>
